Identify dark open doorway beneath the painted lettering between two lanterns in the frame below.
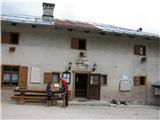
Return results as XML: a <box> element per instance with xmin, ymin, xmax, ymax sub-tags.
<box><xmin>75</xmin><ymin>73</ymin><xmax>88</xmax><ymax>98</ymax></box>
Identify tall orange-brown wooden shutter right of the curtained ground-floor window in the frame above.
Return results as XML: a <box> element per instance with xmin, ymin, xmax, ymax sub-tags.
<box><xmin>19</xmin><ymin>66</ymin><xmax>28</xmax><ymax>89</ymax></box>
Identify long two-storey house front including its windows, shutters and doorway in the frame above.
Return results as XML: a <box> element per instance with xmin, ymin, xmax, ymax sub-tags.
<box><xmin>1</xmin><ymin>2</ymin><xmax>160</xmax><ymax>104</ymax></box>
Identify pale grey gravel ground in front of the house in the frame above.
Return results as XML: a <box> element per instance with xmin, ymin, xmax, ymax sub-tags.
<box><xmin>1</xmin><ymin>102</ymin><xmax>160</xmax><ymax>120</ymax></box>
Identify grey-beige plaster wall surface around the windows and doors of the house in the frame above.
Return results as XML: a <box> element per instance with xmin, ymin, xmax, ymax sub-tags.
<box><xmin>1</xmin><ymin>24</ymin><xmax>160</xmax><ymax>104</ymax></box>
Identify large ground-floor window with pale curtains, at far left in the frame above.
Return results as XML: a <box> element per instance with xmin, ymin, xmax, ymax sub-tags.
<box><xmin>2</xmin><ymin>66</ymin><xmax>19</xmax><ymax>86</ymax></box>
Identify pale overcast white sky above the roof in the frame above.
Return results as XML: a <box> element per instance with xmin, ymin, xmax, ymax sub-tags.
<box><xmin>1</xmin><ymin>0</ymin><xmax>160</xmax><ymax>35</ymax></box>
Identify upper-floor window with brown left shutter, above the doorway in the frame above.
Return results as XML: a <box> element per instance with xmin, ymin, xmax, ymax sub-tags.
<box><xmin>71</xmin><ymin>38</ymin><xmax>87</xmax><ymax>50</ymax></box>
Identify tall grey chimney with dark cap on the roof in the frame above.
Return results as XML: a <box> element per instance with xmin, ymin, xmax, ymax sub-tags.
<box><xmin>42</xmin><ymin>3</ymin><xmax>55</xmax><ymax>22</ymax></box>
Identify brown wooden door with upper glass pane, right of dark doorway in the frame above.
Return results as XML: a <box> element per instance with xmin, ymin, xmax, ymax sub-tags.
<box><xmin>87</xmin><ymin>74</ymin><xmax>100</xmax><ymax>100</ymax></box>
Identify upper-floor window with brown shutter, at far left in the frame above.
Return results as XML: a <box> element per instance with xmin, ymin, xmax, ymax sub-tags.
<box><xmin>2</xmin><ymin>32</ymin><xmax>19</xmax><ymax>44</ymax></box>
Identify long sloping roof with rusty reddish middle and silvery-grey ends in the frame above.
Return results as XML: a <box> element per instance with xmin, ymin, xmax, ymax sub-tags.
<box><xmin>1</xmin><ymin>15</ymin><xmax>160</xmax><ymax>38</ymax></box>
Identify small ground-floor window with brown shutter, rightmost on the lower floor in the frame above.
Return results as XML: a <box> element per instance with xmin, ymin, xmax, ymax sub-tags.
<box><xmin>134</xmin><ymin>76</ymin><xmax>146</xmax><ymax>86</ymax></box>
